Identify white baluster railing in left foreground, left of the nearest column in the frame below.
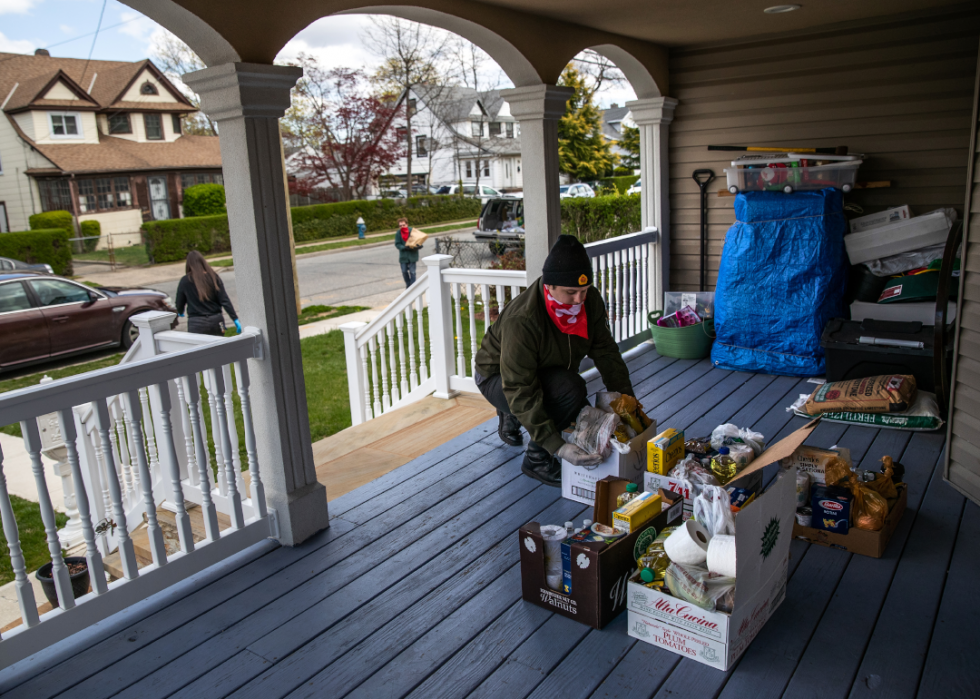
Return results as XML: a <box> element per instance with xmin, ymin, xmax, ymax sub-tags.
<box><xmin>0</xmin><ymin>313</ymin><xmax>276</xmax><ymax>665</ymax></box>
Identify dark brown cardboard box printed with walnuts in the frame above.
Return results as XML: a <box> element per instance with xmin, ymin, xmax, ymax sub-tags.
<box><xmin>518</xmin><ymin>476</ymin><xmax>681</xmax><ymax>629</ymax></box>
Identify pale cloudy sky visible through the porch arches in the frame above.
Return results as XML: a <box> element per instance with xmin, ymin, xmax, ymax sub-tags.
<box><xmin>0</xmin><ymin>0</ymin><xmax>635</xmax><ymax>107</ymax></box>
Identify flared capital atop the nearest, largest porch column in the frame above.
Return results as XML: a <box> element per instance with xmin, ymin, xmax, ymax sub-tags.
<box><xmin>182</xmin><ymin>63</ymin><xmax>303</xmax><ymax>122</ymax></box>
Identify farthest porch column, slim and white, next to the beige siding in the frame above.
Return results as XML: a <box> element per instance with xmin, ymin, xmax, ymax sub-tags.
<box><xmin>626</xmin><ymin>97</ymin><xmax>677</xmax><ymax>298</ymax></box>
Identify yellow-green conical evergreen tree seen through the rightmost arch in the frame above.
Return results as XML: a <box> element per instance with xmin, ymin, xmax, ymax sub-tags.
<box><xmin>558</xmin><ymin>65</ymin><xmax>617</xmax><ymax>180</ymax></box>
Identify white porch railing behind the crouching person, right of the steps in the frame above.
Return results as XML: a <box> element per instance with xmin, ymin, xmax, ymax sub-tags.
<box><xmin>340</xmin><ymin>229</ymin><xmax>660</xmax><ymax>425</ymax></box>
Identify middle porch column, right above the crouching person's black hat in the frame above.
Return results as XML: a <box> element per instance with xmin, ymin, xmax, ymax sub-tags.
<box><xmin>500</xmin><ymin>85</ymin><xmax>574</xmax><ymax>282</ymax></box>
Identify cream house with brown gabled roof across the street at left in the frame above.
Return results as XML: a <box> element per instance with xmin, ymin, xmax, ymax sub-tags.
<box><xmin>0</xmin><ymin>49</ymin><xmax>223</xmax><ymax>245</ymax></box>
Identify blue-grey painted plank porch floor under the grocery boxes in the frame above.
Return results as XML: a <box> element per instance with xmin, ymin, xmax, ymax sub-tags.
<box><xmin>0</xmin><ymin>349</ymin><xmax>980</xmax><ymax>699</ymax></box>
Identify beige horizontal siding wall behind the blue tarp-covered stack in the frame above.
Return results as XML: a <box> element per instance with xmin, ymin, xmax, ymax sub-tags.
<box><xmin>669</xmin><ymin>7</ymin><xmax>980</xmax><ymax>290</ymax></box>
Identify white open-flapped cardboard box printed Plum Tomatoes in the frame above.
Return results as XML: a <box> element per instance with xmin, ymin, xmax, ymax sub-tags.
<box><xmin>627</xmin><ymin>420</ymin><xmax>819</xmax><ymax>670</ymax></box>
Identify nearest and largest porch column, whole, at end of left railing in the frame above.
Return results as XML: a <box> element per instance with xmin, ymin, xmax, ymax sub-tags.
<box><xmin>184</xmin><ymin>63</ymin><xmax>328</xmax><ymax>546</ymax></box>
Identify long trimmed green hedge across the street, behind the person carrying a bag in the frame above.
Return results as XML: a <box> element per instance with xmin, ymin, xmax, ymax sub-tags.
<box><xmin>143</xmin><ymin>194</ymin><xmax>482</xmax><ymax>263</ymax></box>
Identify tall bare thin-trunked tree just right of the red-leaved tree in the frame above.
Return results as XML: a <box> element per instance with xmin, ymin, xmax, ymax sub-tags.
<box><xmin>363</xmin><ymin>16</ymin><xmax>450</xmax><ymax>196</ymax></box>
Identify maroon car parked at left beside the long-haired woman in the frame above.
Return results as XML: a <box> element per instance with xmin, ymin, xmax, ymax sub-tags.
<box><xmin>0</xmin><ymin>271</ymin><xmax>177</xmax><ymax>370</ymax></box>
